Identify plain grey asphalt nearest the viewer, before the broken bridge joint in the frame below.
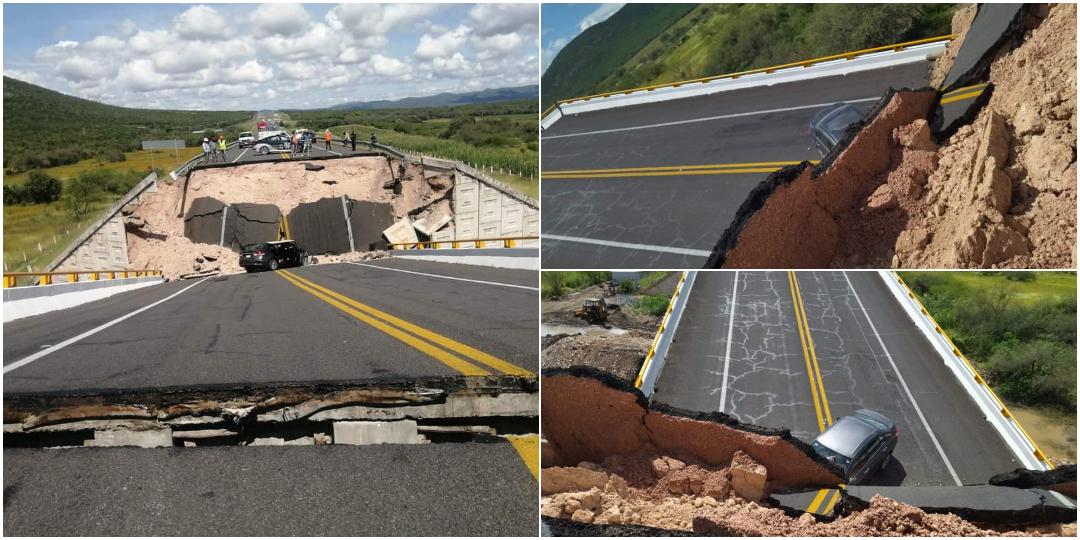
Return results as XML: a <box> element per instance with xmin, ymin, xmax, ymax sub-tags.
<box><xmin>3</xmin><ymin>442</ymin><xmax>538</xmax><ymax>537</ymax></box>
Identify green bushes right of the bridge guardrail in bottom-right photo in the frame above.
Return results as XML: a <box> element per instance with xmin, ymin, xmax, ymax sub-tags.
<box><xmin>902</xmin><ymin>272</ymin><xmax>1077</xmax><ymax>413</ymax></box>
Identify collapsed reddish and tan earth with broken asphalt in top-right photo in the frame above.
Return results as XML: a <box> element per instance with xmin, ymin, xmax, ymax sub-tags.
<box><xmin>706</xmin><ymin>4</ymin><xmax>1077</xmax><ymax>268</ymax></box>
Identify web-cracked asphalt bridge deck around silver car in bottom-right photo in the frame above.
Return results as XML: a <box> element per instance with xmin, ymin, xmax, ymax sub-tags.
<box><xmin>652</xmin><ymin>271</ymin><xmax>1020</xmax><ymax>485</ymax></box>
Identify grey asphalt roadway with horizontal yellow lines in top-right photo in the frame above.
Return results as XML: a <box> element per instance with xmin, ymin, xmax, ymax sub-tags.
<box><xmin>541</xmin><ymin>62</ymin><xmax>977</xmax><ymax>269</ymax></box>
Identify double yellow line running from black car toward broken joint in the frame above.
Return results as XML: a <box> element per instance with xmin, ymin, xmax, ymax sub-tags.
<box><xmin>275</xmin><ymin>270</ymin><xmax>536</xmax><ymax>377</ymax></box>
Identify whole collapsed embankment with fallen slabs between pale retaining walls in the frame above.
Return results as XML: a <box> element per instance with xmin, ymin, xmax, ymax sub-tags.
<box><xmin>50</xmin><ymin>147</ymin><xmax>539</xmax><ymax>279</ymax></box>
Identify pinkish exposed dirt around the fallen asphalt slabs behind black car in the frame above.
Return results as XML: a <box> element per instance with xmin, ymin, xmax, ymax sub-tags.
<box><xmin>123</xmin><ymin>157</ymin><xmax>454</xmax><ymax>280</ymax></box>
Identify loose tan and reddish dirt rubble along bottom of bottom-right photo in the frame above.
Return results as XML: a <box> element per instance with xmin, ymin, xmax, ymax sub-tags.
<box><xmin>540</xmin><ymin>451</ymin><xmax>1076</xmax><ymax>537</ymax></box>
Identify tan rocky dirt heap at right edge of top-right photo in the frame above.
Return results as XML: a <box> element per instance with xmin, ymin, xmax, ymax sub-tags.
<box><xmin>892</xmin><ymin>4</ymin><xmax>1077</xmax><ymax>268</ymax></box>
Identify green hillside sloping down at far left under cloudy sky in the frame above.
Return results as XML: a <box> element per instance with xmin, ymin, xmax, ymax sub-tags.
<box><xmin>3</xmin><ymin>77</ymin><xmax>255</xmax><ymax>174</ymax></box>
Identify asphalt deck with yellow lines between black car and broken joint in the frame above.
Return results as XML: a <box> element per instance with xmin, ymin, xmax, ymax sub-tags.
<box><xmin>3</xmin><ymin>259</ymin><xmax>538</xmax><ymax>394</ymax></box>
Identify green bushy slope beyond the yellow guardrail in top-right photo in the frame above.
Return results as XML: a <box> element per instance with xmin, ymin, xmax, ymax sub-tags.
<box><xmin>543</xmin><ymin>3</ymin><xmax>955</xmax><ymax>107</ymax></box>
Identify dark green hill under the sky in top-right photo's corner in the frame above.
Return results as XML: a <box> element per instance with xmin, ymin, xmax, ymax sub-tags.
<box><xmin>540</xmin><ymin>3</ymin><xmax>696</xmax><ymax>107</ymax></box>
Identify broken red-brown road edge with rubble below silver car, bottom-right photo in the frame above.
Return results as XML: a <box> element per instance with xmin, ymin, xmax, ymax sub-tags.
<box><xmin>541</xmin><ymin>367</ymin><xmax>1076</xmax><ymax>536</ymax></box>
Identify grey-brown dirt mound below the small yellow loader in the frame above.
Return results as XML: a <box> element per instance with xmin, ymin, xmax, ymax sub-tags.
<box><xmin>540</xmin><ymin>330</ymin><xmax>652</xmax><ymax>382</ymax></box>
